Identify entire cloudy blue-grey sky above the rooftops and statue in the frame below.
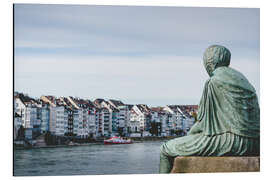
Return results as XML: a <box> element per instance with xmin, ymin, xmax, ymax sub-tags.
<box><xmin>14</xmin><ymin>4</ymin><xmax>260</xmax><ymax>106</ymax></box>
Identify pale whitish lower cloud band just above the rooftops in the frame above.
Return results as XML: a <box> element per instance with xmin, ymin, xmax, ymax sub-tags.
<box><xmin>15</xmin><ymin>56</ymin><xmax>259</xmax><ymax>105</ymax></box>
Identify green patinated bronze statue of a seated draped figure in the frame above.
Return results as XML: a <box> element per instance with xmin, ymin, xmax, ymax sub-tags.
<box><xmin>159</xmin><ymin>45</ymin><xmax>260</xmax><ymax>173</ymax></box>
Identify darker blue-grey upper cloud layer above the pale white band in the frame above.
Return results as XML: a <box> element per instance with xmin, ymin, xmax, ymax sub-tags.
<box><xmin>15</xmin><ymin>5</ymin><xmax>259</xmax><ymax>56</ymax></box>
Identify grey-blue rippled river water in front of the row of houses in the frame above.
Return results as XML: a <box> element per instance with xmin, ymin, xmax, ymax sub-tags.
<box><xmin>14</xmin><ymin>141</ymin><xmax>165</xmax><ymax>176</ymax></box>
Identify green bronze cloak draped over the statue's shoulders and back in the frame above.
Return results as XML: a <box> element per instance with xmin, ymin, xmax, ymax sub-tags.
<box><xmin>194</xmin><ymin>67</ymin><xmax>260</xmax><ymax>138</ymax></box>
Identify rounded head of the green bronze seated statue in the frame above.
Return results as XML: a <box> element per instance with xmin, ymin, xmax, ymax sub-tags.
<box><xmin>203</xmin><ymin>45</ymin><xmax>231</xmax><ymax>76</ymax></box>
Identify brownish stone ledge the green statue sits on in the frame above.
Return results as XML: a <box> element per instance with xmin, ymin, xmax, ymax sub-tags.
<box><xmin>171</xmin><ymin>156</ymin><xmax>260</xmax><ymax>173</ymax></box>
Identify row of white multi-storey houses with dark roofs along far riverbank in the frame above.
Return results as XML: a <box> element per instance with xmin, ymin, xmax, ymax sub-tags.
<box><xmin>14</xmin><ymin>93</ymin><xmax>198</xmax><ymax>139</ymax></box>
